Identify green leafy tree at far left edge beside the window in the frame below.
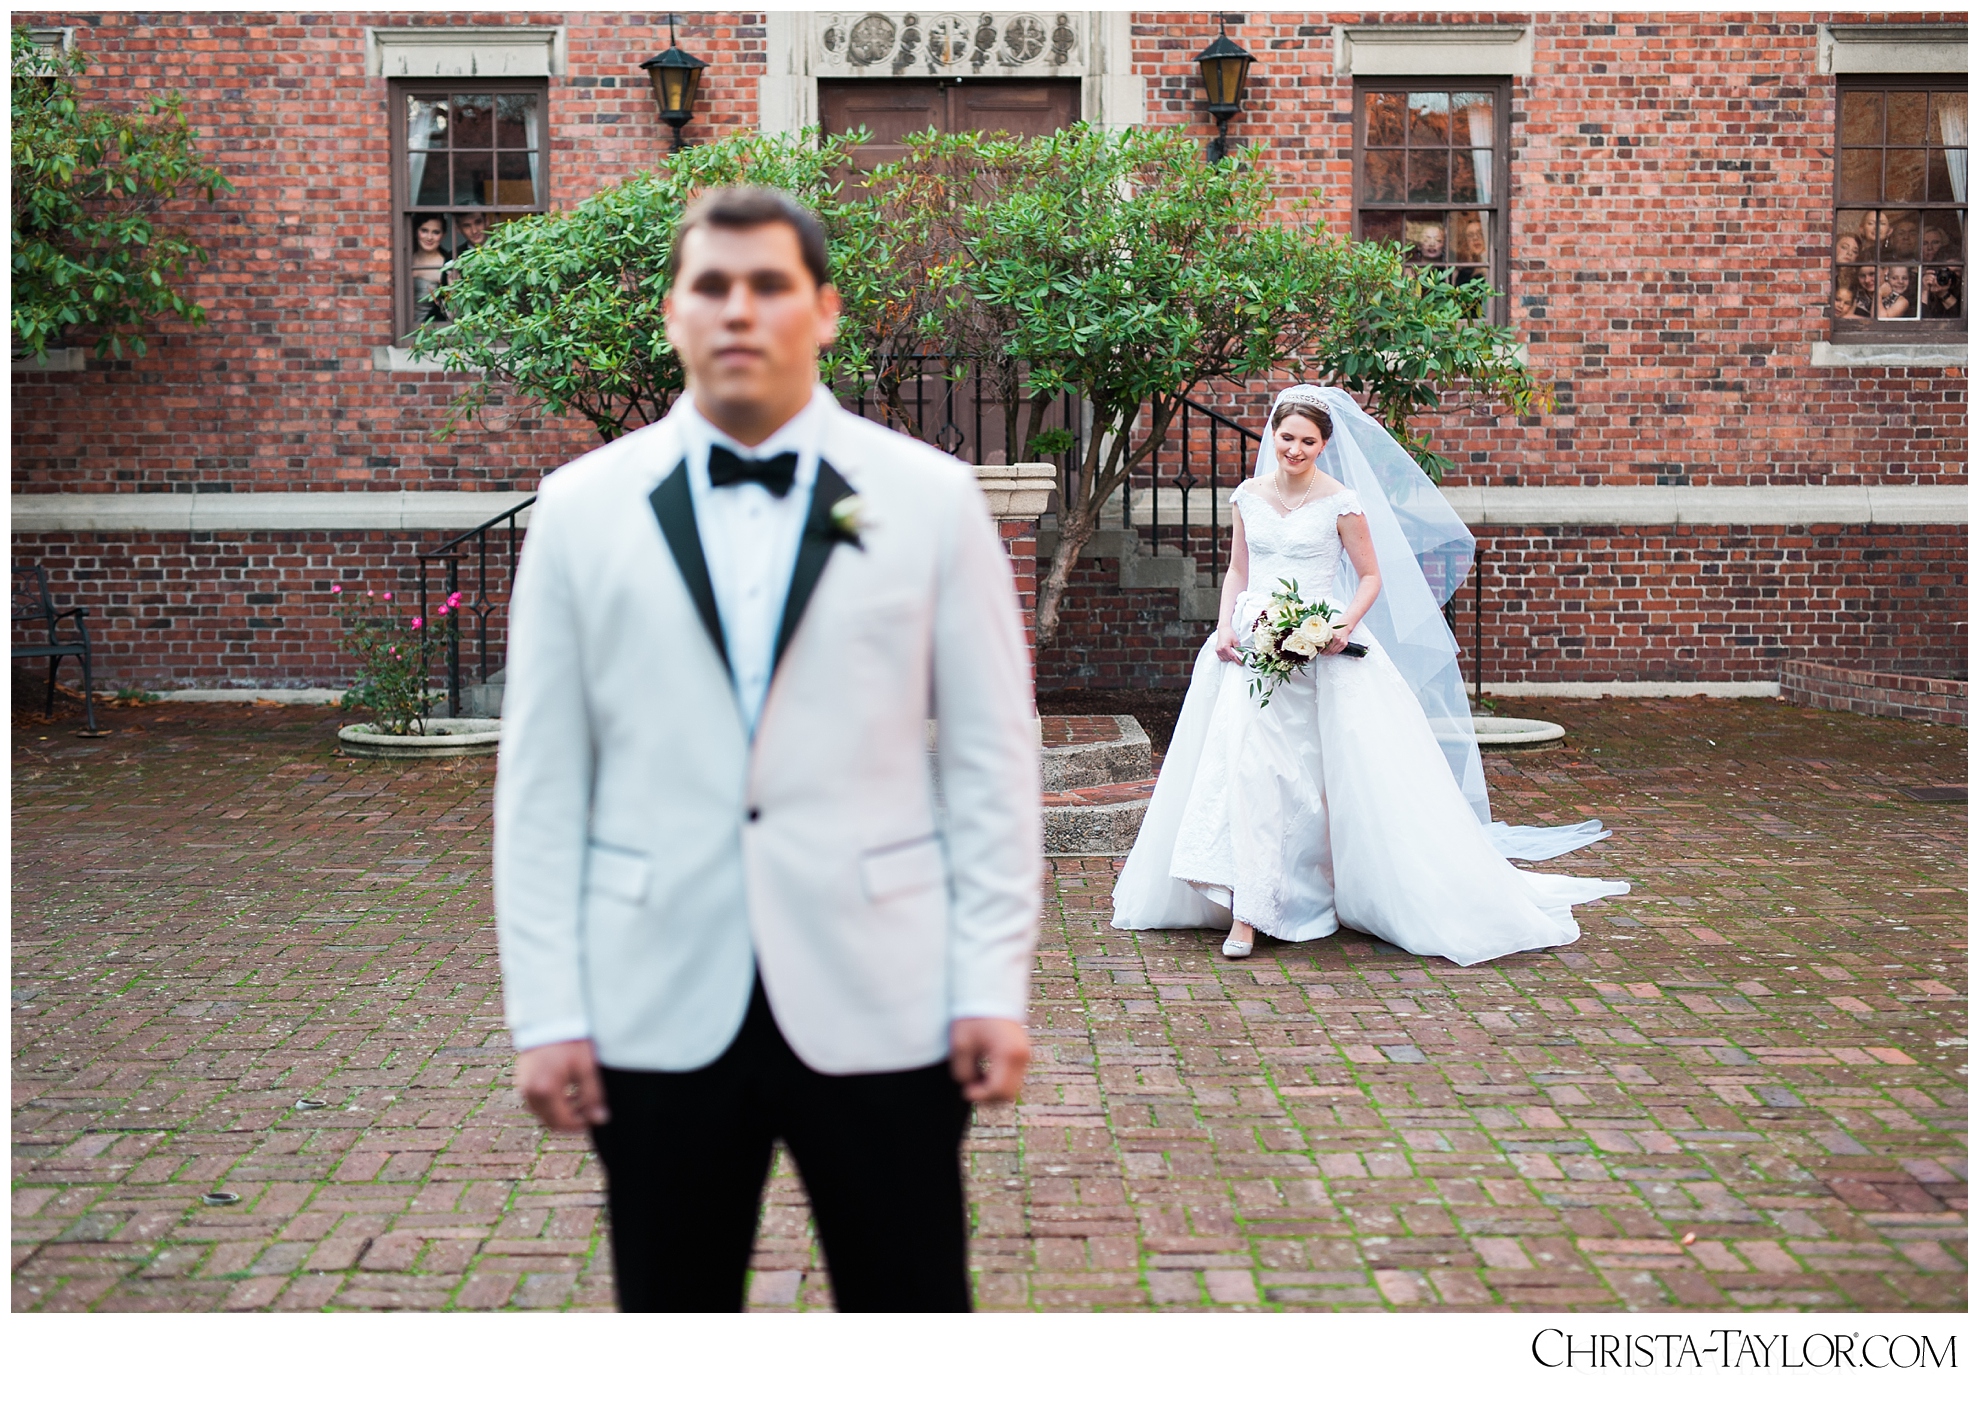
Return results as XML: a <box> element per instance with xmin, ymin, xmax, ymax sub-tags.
<box><xmin>12</xmin><ymin>28</ymin><xmax>234</xmax><ymax>362</ymax></box>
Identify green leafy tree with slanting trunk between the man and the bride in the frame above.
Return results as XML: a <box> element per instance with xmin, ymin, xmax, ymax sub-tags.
<box><xmin>964</xmin><ymin>127</ymin><xmax>1538</xmax><ymax>648</ymax></box>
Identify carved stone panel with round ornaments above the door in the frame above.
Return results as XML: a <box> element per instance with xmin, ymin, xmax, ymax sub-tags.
<box><xmin>811</xmin><ymin>10</ymin><xmax>1090</xmax><ymax>77</ymax></box>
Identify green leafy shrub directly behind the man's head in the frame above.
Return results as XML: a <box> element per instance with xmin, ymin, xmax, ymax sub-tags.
<box><xmin>410</xmin><ymin>129</ymin><xmax>896</xmax><ymax>440</ymax></box>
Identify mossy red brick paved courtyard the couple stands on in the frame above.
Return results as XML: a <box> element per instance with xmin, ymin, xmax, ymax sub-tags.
<box><xmin>12</xmin><ymin>701</ymin><xmax>1967</xmax><ymax>1309</ymax></box>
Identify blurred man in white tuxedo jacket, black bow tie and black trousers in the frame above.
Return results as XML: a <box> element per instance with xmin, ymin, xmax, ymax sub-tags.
<box><xmin>495</xmin><ymin>188</ymin><xmax>1043</xmax><ymax>1311</ymax></box>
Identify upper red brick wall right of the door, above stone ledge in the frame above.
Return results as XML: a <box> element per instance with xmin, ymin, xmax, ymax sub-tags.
<box><xmin>1134</xmin><ymin>12</ymin><xmax>1965</xmax><ymax>487</ymax></box>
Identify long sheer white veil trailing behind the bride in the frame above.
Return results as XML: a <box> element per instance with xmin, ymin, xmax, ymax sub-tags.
<box><xmin>1255</xmin><ymin>384</ymin><xmax>1609</xmax><ymax>861</ymax></box>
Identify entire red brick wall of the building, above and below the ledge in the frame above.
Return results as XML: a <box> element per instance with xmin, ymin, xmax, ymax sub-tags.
<box><xmin>12</xmin><ymin>12</ymin><xmax>1965</xmax><ymax>685</ymax></box>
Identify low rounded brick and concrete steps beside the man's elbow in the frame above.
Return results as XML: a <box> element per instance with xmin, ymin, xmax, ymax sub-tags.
<box><xmin>1039</xmin><ymin>715</ymin><xmax>1154</xmax><ymax>853</ymax></box>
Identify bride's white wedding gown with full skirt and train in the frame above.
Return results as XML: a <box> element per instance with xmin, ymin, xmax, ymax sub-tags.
<box><xmin>1112</xmin><ymin>487</ymin><xmax>1629</xmax><ymax>964</ymax></box>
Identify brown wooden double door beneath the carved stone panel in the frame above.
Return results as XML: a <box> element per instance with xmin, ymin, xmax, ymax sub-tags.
<box><xmin>817</xmin><ymin>77</ymin><xmax>1079</xmax><ymax>170</ymax></box>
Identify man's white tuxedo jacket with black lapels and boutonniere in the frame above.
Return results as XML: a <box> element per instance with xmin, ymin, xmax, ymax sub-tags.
<box><xmin>495</xmin><ymin>394</ymin><xmax>1043</xmax><ymax>1073</ymax></box>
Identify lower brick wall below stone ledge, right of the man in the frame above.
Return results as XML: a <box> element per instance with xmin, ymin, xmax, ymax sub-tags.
<box><xmin>1037</xmin><ymin>527</ymin><xmax>1967</xmax><ymax>691</ymax></box>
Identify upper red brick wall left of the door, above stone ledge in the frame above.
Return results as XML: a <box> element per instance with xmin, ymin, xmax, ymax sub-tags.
<box><xmin>14</xmin><ymin>12</ymin><xmax>764</xmax><ymax>491</ymax></box>
